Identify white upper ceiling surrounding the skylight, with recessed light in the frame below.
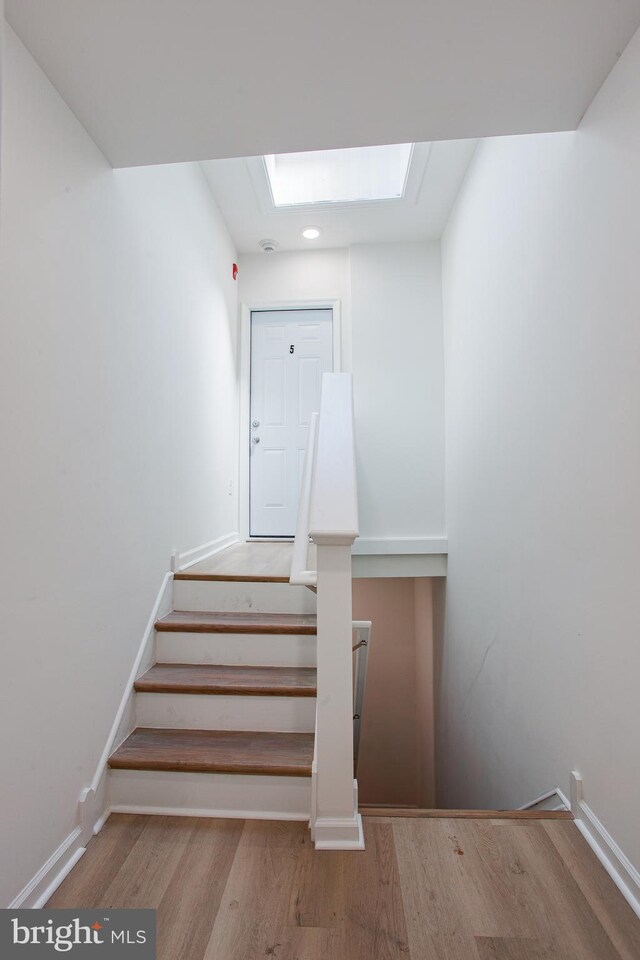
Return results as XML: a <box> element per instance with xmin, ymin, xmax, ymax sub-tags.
<box><xmin>201</xmin><ymin>140</ymin><xmax>477</xmax><ymax>253</ymax></box>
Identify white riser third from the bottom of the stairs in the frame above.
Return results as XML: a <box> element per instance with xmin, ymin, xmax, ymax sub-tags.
<box><xmin>156</xmin><ymin>631</ymin><xmax>316</xmax><ymax>667</ymax></box>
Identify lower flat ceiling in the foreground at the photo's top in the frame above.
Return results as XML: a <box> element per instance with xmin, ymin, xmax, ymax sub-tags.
<box><xmin>5</xmin><ymin>0</ymin><xmax>640</xmax><ymax>166</ymax></box>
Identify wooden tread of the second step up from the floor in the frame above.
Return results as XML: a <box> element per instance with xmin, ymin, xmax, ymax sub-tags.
<box><xmin>134</xmin><ymin>663</ymin><xmax>316</xmax><ymax>697</ymax></box>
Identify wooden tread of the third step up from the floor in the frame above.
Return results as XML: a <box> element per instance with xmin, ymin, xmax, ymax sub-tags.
<box><xmin>155</xmin><ymin>610</ymin><xmax>317</xmax><ymax>636</ymax></box>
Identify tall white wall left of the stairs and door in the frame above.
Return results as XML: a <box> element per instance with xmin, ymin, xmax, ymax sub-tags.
<box><xmin>0</xmin><ymin>29</ymin><xmax>238</xmax><ymax>903</ymax></box>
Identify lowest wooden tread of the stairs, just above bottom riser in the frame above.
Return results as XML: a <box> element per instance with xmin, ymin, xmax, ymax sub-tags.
<box><xmin>109</xmin><ymin>727</ymin><xmax>314</xmax><ymax>777</ymax></box>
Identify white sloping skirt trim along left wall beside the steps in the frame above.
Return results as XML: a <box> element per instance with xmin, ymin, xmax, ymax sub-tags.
<box><xmin>78</xmin><ymin>572</ymin><xmax>173</xmax><ymax>844</ymax></box>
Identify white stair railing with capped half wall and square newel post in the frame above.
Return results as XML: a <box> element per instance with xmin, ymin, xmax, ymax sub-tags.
<box><xmin>290</xmin><ymin>373</ymin><xmax>364</xmax><ymax>850</ymax></box>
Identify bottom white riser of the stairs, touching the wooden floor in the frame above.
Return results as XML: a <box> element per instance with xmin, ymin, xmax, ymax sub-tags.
<box><xmin>109</xmin><ymin>770</ymin><xmax>311</xmax><ymax>820</ymax></box>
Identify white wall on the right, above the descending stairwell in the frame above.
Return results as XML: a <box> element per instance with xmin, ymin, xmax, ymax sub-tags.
<box><xmin>439</xmin><ymin>28</ymin><xmax>640</xmax><ymax>865</ymax></box>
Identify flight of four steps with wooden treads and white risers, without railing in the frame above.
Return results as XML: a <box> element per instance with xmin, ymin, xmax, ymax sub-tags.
<box><xmin>108</xmin><ymin>572</ymin><xmax>317</xmax><ymax>820</ymax></box>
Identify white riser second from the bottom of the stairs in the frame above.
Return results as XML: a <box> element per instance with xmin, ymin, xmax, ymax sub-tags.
<box><xmin>136</xmin><ymin>693</ymin><xmax>316</xmax><ymax>733</ymax></box>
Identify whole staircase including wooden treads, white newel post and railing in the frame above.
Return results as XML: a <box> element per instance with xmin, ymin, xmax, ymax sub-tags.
<box><xmin>105</xmin><ymin>373</ymin><xmax>364</xmax><ymax>850</ymax></box>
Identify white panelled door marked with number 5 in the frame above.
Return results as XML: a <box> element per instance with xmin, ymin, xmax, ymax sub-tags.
<box><xmin>249</xmin><ymin>310</ymin><xmax>333</xmax><ymax>537</ymax></box>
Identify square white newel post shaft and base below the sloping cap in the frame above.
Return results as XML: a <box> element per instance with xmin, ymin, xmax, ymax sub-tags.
<box><xmin>312</xmin><ymin>536</ymin><xmax>364</xmax><ymax>850</ymax></box>
